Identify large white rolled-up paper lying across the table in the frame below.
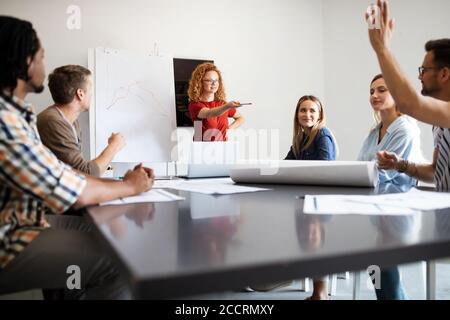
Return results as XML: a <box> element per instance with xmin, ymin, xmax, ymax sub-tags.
<box><xmin>230</xmin><ymin>160</ymin><xmax>378</xmax><ymax>188</ymax></box>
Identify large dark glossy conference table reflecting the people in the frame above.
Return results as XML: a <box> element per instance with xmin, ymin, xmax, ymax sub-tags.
<box><xmin>87</xmin><ymin>181</ymin><xmax>450</xmax><ymax>299</ymax></box>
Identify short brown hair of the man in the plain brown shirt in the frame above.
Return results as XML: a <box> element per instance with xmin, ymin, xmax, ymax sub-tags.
<box><xmin>48</xmin><ymin>65</ymin><xmax>91</xmax><ymax>104</ymax></box>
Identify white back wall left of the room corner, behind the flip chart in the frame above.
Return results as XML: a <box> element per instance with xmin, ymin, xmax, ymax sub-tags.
<box><xmin>0</xmin><ymin>0</ymin><xmax>324</xmax><ymax>170</ymax></box>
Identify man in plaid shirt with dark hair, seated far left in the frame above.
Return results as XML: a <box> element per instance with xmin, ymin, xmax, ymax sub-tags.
<box><xmin>0</xmin><ymin>16</ymin><xmax>154</xmax><ymax>299</ymax></box>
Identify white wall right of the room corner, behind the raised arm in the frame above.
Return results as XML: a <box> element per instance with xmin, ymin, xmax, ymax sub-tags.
<box><xmin>323</xmin><ymin>0</ymin><xmax>450</xmax><ymax>160</ymax></box>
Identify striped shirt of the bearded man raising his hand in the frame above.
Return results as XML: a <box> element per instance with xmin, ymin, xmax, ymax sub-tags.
<box><xmin>433</xmin><ymin>127</ymin><xmax>450</xmax><ymax>192</ymax></box>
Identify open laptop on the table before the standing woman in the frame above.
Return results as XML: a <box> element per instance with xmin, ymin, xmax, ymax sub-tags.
<box><xmin>180</xmin><ymin>142</ymin><xmax>239</xmax><ymax>178</ymax></box>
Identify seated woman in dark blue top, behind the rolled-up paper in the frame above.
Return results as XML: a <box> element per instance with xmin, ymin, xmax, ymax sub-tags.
<box><xmin>285</xmin><ymin>96</ymin><xmax>336</xmax><ymax>160</ymax></box>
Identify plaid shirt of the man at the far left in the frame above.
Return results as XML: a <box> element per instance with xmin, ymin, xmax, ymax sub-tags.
<box><xmin>0</xmin><ymin>93</ymin><xmax>86</xmax><ymax>270</ymax></box>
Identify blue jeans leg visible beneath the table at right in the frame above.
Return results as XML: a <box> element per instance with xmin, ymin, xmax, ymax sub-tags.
<box><xmin>375</xmin><ymin>266</ymin><xmax>408</xmax><ymax>300</ymax></box>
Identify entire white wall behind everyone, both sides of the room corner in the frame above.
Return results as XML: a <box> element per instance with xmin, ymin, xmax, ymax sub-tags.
<box><xmin>0</xmin><ymin>0</ymin><xmax>450</xmax><ymax>165</ymax></box>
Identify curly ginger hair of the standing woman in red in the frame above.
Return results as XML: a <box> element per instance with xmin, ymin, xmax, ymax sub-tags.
<box><xmin>188</xmin><ymin>62</ymin><xmax>226</xmax><ymax>102</ymax></box>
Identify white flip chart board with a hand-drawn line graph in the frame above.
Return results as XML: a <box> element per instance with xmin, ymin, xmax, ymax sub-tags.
<box><xmin>89</xmin><ymin>48</ymin><xmax>176</xmax><ymax>163</ymax></box>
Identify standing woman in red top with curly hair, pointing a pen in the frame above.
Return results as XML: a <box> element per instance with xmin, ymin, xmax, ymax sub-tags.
<box><xmin>188</xmin><ymin>63</ymin><xmax>244</xmax><ymax>141</ymax></box>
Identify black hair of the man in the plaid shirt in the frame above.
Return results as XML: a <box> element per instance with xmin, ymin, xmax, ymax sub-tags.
<box><xmin>0</xmin><ymin>16</ymin><xmax>41</xmax><ymax>91</ymax></box>
